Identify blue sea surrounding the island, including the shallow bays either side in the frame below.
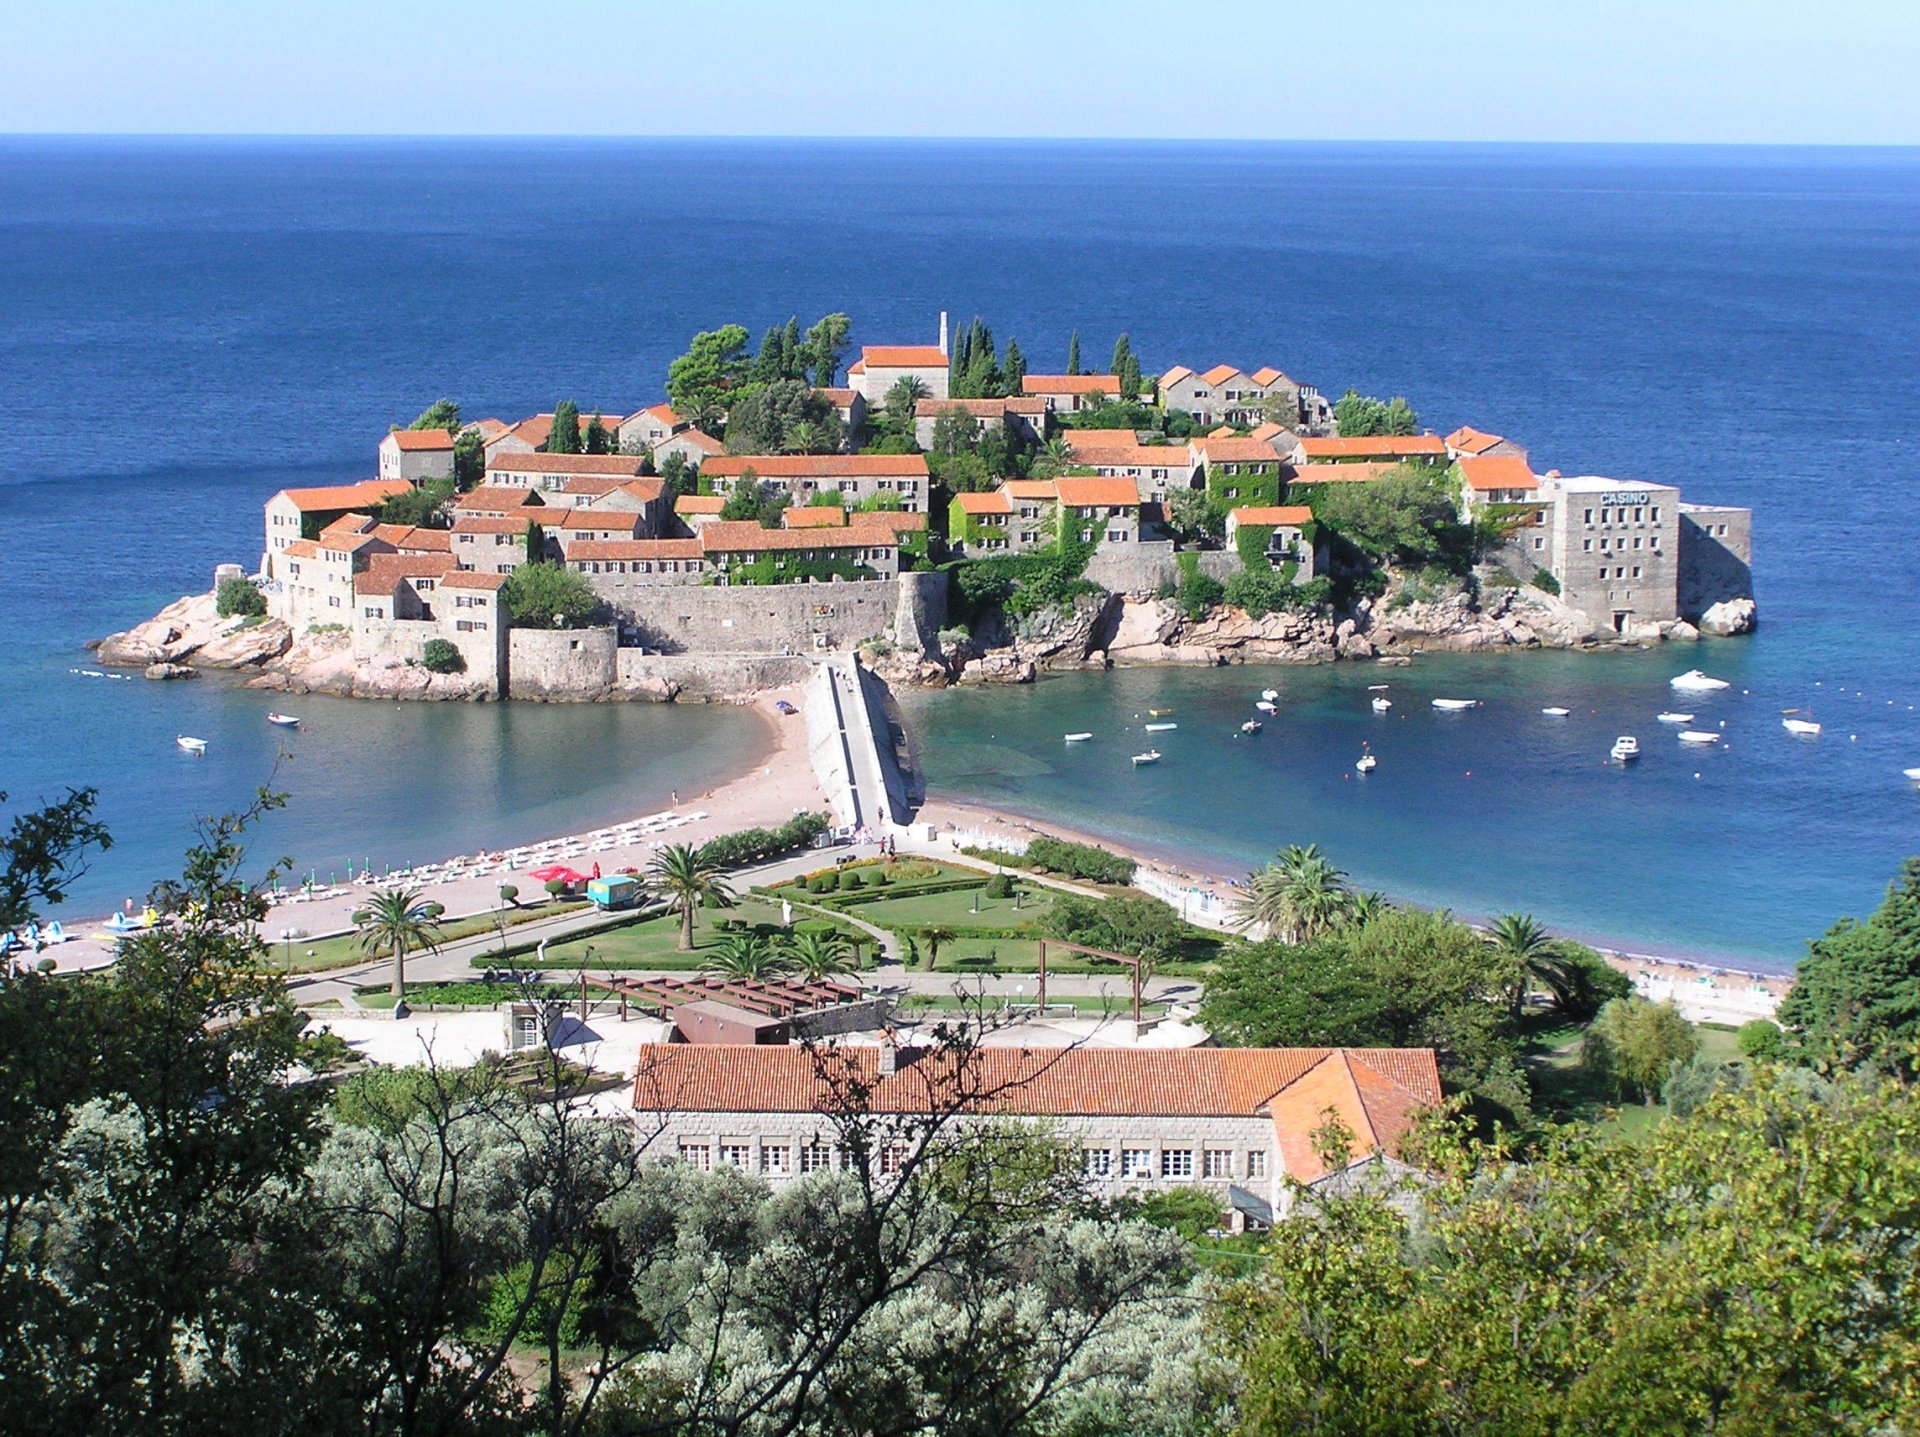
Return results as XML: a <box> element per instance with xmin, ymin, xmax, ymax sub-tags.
<box><xmin>0</xmin><ymin>138</ymin><xmax>1920</xmax><ymax>968</ymax></box>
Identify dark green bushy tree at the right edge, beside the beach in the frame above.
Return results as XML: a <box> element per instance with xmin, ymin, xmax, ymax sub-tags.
<box><xmin>1778</xmin><ymin>859</ymin><xmax>1920</xmax><ymax>1076</ymax></box>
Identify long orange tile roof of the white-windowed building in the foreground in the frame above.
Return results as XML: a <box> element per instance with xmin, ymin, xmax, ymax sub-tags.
<box><xmin>634</xmin><ymin>1043</ymin><xmax>1440</xmax><ymax>1147</ymax></box>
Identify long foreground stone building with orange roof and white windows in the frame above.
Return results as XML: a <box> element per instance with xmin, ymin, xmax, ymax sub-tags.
<box><xmin>634</xmin><ymin>1043</ymin><xmax>1440</xmax><ymax>1228</ymax></box>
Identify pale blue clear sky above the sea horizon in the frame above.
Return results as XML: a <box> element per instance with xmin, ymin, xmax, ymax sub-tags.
<box><xmin>0</xmin><ymin>0</ymin><xmax>1920</xmax><ymax>144</ymax></box>
